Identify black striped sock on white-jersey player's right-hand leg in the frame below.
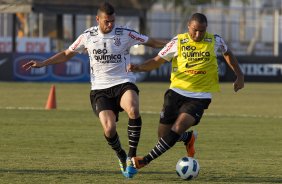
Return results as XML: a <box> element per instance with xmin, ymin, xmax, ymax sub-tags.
<box><xmin>127</xmin><ymin>117</ymin><xmax>142</xmax><ymax>157</ymax></box>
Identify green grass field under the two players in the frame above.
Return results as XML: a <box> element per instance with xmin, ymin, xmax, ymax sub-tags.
<box><xmin>0</xmin><ymin>82</ymin><xmax>282</xmax><ymax>184</ymax></box>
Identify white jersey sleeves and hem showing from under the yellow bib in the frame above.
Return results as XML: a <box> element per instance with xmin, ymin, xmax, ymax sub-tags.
<box><xmin>158</xmin><ymin>35</ymin><xmax>228</xmax><ymax>99</ymax></box>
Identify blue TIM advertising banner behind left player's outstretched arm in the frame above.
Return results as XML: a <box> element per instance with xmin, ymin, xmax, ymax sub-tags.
<box><xmin>13</xmin><ymin>53</ymin><xmax>90</xmax><ymax>82</ymax></box>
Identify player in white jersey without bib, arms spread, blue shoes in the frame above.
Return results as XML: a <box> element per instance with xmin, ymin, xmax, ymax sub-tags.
<box><xmin>23</xmin><ymin>2</ymin><xmax>166</xmax><ymax>178</ymax></box>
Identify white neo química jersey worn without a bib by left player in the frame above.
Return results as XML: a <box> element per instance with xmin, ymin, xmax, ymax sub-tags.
<box><xmin>69</xmin><ymin>26</ymin><xmax>148</xmax><ymax>90</ymax></box>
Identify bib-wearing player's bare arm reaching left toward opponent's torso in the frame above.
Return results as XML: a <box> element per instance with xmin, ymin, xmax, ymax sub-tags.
<box><xmin>127</xmin><ymin>56</ymin><xmax>166</xmax><ymax>72</ymax></box>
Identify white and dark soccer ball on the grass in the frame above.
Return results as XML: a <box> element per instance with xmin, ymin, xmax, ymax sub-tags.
<box><xmin>176</xmin><ymin>156</ymin><xmax>200</xmax><ymax>180</ymax></box>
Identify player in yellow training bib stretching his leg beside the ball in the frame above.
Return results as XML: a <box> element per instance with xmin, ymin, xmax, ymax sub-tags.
<box><xmin>127</xmin><ymin>13</ymin><xmax>244</xmax><ymax>169</ymax></box>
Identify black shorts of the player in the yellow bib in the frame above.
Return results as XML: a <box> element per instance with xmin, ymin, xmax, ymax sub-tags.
<box><xmin>160</xmin><ymin>89</ymin><xmax>211</xmax><ymax>125</ymax></box>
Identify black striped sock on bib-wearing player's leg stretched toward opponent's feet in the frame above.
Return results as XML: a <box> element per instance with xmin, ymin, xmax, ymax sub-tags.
<box><xmin>144</xmin><ymin>130</ymin><xmax>180</xmax><ymax>163</ymax></box>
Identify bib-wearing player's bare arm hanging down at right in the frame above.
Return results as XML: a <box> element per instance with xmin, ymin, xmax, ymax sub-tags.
<box><xmin>223</xmin><ymin>50</ymin><xmax>244</xmax><ymax>92</ymax></box>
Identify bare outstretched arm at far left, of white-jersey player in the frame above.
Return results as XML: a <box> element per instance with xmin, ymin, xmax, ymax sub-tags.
<box><xmin>22</xmin><ymin>49</ymin><xmax>76</xmax><ymax>70</ymax></box>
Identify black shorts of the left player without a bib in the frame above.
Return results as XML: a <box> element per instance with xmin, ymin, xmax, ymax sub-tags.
<box><xmin>90</xmin><ymin>82</ymin><xmax>139</xmax><ymax>121</ymax></box>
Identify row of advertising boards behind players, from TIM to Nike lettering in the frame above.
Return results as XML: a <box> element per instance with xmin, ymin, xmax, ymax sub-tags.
<box><xmin>7</xmin><ymin>53</ymin><xmax>282</xmax><ymax>82</ymax></box>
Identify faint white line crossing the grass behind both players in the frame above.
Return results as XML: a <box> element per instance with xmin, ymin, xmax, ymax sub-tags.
<box><xmin>0</xmin><ymin>107</ymin><xmax>282</xmax><ymax>119</ymax></box>
